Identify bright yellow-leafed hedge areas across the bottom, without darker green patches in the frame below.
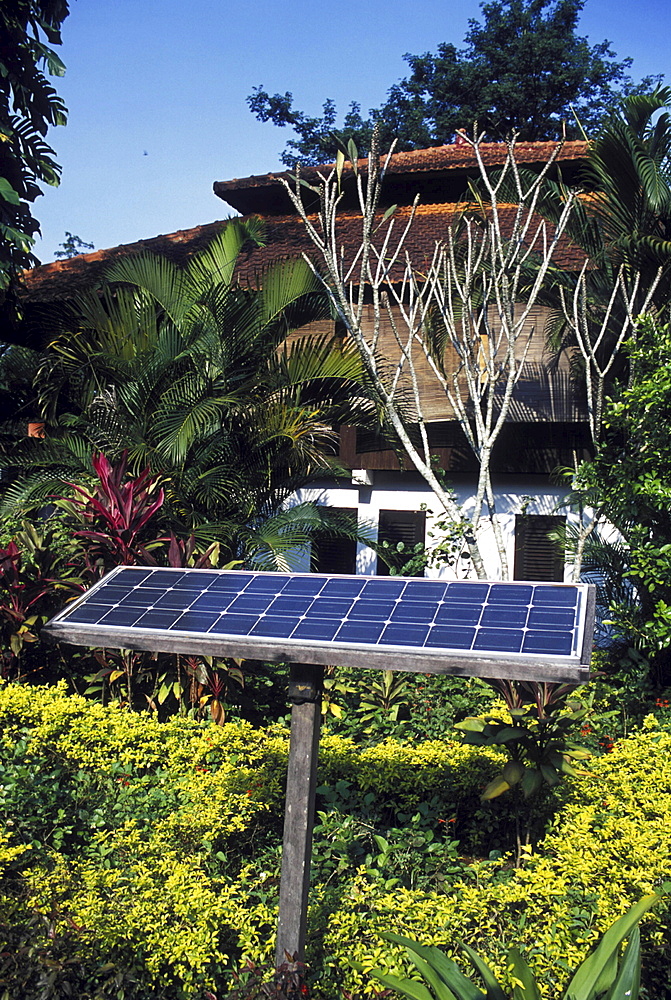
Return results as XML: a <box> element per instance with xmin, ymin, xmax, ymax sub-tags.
<box><xmin>0</xmin><ymin>685</ymin><xmax>671</xmax><ymax>1000</ymax></box>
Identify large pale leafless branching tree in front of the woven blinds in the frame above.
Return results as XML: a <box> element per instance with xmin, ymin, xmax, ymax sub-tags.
<box><xmin>285</xmin><ymin>132</ymin><xmax>575</xmax><ymax>579</ymax></box>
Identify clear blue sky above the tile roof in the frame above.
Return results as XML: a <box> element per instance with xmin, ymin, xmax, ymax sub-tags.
<box><xmin>35</xmin><ymin>0</ymin><xmax>671</xmax><ymax>262</ymax></box>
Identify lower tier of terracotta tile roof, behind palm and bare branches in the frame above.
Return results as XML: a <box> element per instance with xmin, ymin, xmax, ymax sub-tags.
<box><xmin>24</xmin><ymin>197</ymin><xmax>584</xmax><ymax>303</ymax></box>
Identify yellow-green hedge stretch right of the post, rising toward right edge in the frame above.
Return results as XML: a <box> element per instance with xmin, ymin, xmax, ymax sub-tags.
<box><xmin>324</xmin><ymin>722</ymin><xmax>671</xmax><ymax>1000</ymax></box>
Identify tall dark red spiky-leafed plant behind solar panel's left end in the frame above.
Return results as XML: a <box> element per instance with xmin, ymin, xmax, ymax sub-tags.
<box><xmin>69</xmin><ymin>452</ymin><xmax>167</xmax><ymax>568</ymax></box>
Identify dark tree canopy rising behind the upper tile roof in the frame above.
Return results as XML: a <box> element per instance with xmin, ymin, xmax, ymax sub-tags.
<box><xmin>247</xmin><ymin>0</ymin><xmax>655</xmax><ymax>166</ymax></box>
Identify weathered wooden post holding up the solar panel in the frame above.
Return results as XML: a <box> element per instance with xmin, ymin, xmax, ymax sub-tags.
<box><xmin>276</xmin><ymin>663</ymin><xmax>324</xmax><ymax>966</ymax></box>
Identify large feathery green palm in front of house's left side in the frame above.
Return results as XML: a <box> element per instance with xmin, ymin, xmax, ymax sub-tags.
<box><xmin>4</xmin><ymin>219</ymin><xmax>375</xmax><ymax>564</ymax></box>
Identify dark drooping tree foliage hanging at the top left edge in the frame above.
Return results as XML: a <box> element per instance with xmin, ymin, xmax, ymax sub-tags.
<box><xmin>0</xmin><ymin>0</ymin><xmax>69</xmax><ymax>296</ymax></box>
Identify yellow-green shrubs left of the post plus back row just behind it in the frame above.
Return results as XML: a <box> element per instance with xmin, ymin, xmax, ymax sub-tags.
<box><xmin>0</xmin><ymin>684</ymin><xmax>506</xmax><ymax>1000</ymax></box>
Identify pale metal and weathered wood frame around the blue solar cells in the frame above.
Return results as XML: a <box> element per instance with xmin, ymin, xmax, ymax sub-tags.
<box><xmin>43</xmin><ymin>566</ymin><xmax>595</xmax><ymax>683</ymax></box>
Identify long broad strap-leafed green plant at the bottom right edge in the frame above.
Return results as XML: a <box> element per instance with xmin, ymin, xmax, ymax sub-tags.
<box><xmin>362</xmin><ymin>893</ymin><xmax>660</xmax><ymax>1000</ymax></box>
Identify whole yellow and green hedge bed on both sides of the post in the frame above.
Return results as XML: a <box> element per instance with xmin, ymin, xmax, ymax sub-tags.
<box><xmin>0</xmin><ymin>685</ymin><xmax>671</xmax><ymax>1000</ymax></box>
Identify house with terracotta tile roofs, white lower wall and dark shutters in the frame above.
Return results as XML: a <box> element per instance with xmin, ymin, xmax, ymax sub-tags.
<box><xmin>19</xmin><ymin>142</ymin><xmax>589</xmax><ymax>580</ymax></box>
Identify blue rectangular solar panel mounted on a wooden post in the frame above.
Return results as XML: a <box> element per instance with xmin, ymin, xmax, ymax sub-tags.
<box><xmin>45</xmin><ymin>566</ymin><xmax>594</xmax><ymax>680</ymax></box>
